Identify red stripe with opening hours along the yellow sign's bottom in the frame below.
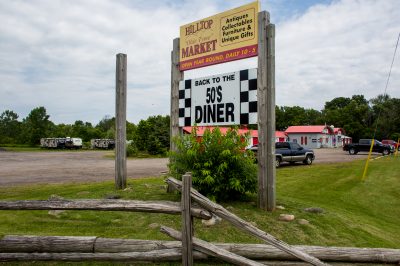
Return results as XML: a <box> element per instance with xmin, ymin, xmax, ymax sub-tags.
<box><xmin>179</xmin><ymin>44</ymin><xmax>258</xmax><ymax>71</ymax></box>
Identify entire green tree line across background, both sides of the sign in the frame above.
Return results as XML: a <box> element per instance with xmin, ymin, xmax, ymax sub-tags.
<box><xmin>0</xmin><ymin>95</ymin><xmax>400</xmax><ymax>154</ymax></box>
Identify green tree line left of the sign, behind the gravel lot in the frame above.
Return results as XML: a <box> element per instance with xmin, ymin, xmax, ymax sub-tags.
<box><xmin>0</xmin><ymin>106</ymin><xmax>170</xmax><ymax>154</ymax></box>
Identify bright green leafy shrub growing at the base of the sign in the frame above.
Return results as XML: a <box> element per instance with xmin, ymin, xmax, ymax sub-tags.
<box><xmin>168</xmin><ymin>127</ymin><xmax>257</xmax><ymax>200</ymax></box>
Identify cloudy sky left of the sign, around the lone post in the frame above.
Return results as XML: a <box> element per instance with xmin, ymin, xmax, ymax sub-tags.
<box><xmin>0</xmin><ymin>0</ymin><xmax>222</xmax><ymax>123</ymax></box>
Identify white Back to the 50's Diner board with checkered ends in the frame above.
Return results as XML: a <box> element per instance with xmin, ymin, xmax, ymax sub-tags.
<box><xmin>179</xmin><ymin>69</ymin><xmax>257</xmax><ymax>127</ymax></box>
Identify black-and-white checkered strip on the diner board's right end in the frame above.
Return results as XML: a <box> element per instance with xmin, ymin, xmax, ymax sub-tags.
<box><xmin>240</xmin><ymin>68</ymin><xmax>257</xmax><ymax>125</ymax></box>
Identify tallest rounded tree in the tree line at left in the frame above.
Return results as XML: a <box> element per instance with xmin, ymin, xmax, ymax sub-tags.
<box><xmin>22</xmin><ymin>106</ymin><xmax>54</xmax><ymax>145</ymax></box>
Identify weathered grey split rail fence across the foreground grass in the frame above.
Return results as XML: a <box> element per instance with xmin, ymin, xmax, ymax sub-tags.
<box><xmin>0</xmin><ymin>173</ymin><xmax>400</xmax><ymax>265</ymax></box>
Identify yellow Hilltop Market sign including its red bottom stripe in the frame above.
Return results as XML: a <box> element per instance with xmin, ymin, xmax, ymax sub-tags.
<box><xmin>179</xmin><ymin>1</ymin><xmax>259</xmax><ymax>71</ymax></box>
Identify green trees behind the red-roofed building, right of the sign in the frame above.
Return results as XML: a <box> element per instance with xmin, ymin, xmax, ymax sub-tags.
<box><xmin>275</xmin><ymin>95</ymin><xmax>400</xmax><ymax>141</ymax></box>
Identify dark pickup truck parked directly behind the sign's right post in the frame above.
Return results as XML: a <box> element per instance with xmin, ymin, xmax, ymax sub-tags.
<box><xmin>250</xmin><ymin>142</ymin><xmax>315</xmax><ymax>167</ymax></box>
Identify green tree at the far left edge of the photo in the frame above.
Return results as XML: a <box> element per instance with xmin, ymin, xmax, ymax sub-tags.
<box><xmin>0</xmin><ymin>110</ymin><xmax>21</xmax><ymax>144</ymax></box>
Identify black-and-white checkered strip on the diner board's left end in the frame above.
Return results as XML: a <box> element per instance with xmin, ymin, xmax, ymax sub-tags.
<box><xmin>179</xmin><ymin>79</ymin><xmax>192</xmax><ymax>127</ymax></box>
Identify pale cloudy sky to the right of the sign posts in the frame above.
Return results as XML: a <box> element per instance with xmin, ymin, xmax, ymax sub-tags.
<box><xmin>276</xmin><ymin>0</ymin><xmax>400</xmax><ymax>109</ymax></box>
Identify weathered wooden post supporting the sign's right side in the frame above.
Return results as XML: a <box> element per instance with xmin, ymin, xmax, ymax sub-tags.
<box><xmin>257</xmin><ymin>11</ymin><xmax>276</xmax><ymax>211</ymax></box>
